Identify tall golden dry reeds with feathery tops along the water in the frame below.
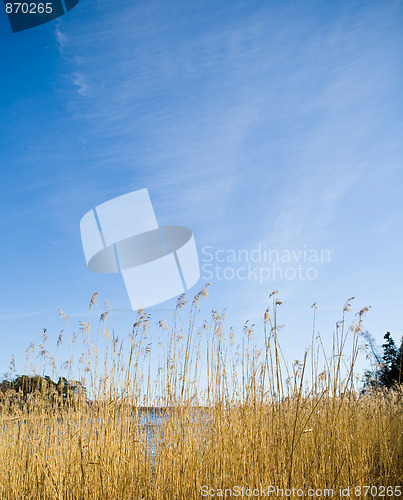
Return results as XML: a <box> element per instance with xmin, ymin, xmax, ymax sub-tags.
<box><xmin>0</xmin><ymin>288</ymin><xmax>403</xmax><ymax>500</ymax></box>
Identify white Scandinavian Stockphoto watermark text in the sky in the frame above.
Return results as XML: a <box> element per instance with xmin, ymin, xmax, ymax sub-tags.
<box><xmin>201</xmin><ymin>243</ymin><xmax>330</xmax><ymax>284</ymax></box>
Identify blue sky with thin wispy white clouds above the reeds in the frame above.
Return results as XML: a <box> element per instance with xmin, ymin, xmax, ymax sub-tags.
<box><xmin>0</xmin><ymin>0</ymin><xmax>403</xmax><ymax>380</ymax></box>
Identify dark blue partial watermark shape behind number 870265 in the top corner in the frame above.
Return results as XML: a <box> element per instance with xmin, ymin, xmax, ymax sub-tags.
<box><xmin>3</xmin><ymin>0</ymin><xmax>79</xmax><ymax>33</ymax></box>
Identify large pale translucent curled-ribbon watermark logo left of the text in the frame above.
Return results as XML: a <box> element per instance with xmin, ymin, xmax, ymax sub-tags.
<box><xmin>80</xmin><ymin>189</ymin><xmax>200</xmax><ymax>311</ymax></box>
